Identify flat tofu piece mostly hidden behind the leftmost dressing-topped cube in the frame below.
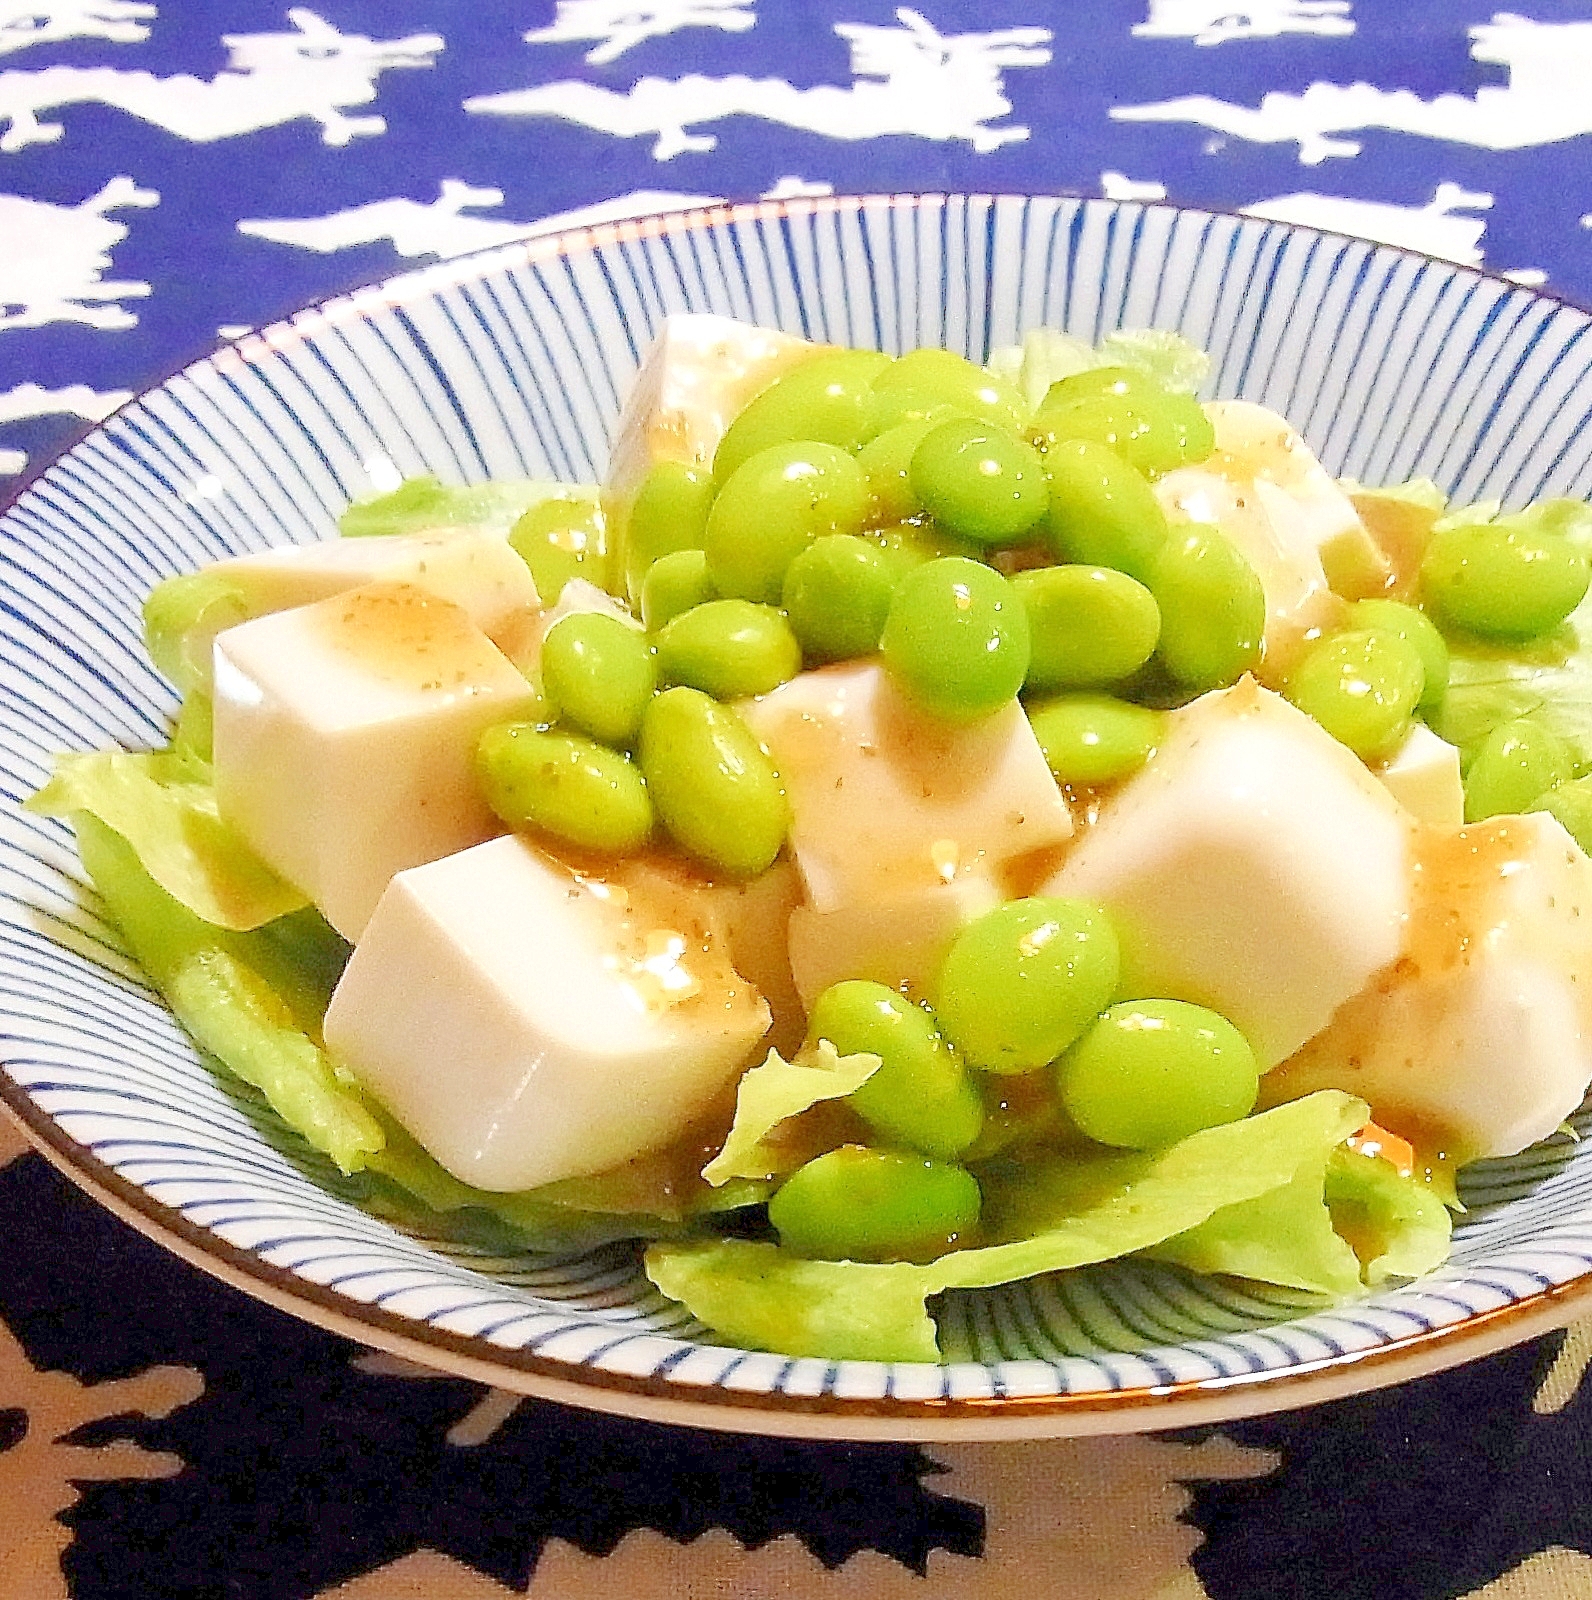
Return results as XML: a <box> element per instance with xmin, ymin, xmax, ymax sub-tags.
<box><xmin>208</xmin><ymin>528</ymin><xmax>541</xmax><ymax>638</ymax></box>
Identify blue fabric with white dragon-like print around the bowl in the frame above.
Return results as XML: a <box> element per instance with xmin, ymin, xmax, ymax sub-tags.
<box><xmin>9</xmin><ymin>0</ymin><xmax>1592</xmax><ymax>1600</ymax></box>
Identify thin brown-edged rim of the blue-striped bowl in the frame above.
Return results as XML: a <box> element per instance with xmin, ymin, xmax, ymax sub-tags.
<box><xmin>0</xmin><ymin>189</ymin><xmax>1592</xmax><ymax>1442</ymax></box>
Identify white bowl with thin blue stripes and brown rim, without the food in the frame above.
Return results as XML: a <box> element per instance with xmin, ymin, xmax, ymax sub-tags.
<box><xmin>0</xmin><ymin>195</ymin><xmax>1592</xmax><ymax>1438</ymax></box>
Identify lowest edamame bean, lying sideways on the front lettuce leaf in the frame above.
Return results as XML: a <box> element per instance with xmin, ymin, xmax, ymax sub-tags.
<box><xmin>768</xmin><ymin>1144</ymin><xmax>982</xmax><ymax>1261</ymax></box>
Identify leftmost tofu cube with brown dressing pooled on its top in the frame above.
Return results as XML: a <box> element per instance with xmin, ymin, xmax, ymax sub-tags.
<box><xmin>214</xmin><ymin>584</ymin><xmax>536</xmax><ymax>939</ymax></box>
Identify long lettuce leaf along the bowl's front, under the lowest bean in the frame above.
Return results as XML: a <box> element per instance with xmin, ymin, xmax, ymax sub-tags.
<box><xmin>646</xmin><ymin>1090</ymin><xmax>1366</xmax><ymax>1362</ymax></box>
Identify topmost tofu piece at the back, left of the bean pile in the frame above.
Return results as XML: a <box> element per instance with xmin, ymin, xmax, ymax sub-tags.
<box><xmin>603</xmin><ymin>312</ymin><xmax>822</xmax><ymax>506</ymax></box>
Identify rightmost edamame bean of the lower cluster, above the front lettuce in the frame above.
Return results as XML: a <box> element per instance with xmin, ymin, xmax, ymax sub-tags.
<box><xmin>1058</xmin><ymin>1000</ymin><xmax>1261</xmax><ymax>1150</ymax></box>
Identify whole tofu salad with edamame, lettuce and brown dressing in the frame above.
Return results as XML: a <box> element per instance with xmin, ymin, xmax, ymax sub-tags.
<box><xmin>30</xmin><ymin>315</ymin><xmax>1592</xmax><ymax>1362</ymax></box>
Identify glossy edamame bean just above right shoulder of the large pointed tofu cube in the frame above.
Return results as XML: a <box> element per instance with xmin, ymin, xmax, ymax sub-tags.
<box><xmin>1285</xmin><ymin>627</ymin><xmax>1426</xmax><ymax>762</ymax></box>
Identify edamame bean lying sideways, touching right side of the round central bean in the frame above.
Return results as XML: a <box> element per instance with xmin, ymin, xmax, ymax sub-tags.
<box><xmin>1011</xmin><ymin>566</ymin><xmax>1162</xmax><ymax>690</ymax></box>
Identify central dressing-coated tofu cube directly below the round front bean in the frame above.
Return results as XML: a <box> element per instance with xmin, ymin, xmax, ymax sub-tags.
<box><xmin>741</xmin><ymin>664</ymin><xmax>1072</xmax><ymax>912</ymax></box>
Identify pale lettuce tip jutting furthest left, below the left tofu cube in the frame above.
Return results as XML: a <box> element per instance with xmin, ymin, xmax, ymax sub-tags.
<box><xmin>27</xmin><ymin>750</ymin><xmax>306</xmax><ymax>931</ymax></box>
